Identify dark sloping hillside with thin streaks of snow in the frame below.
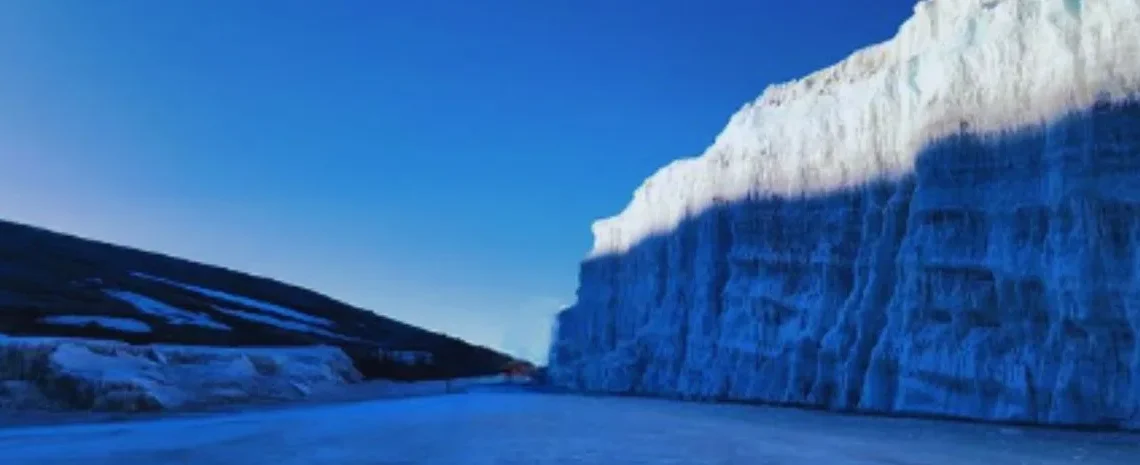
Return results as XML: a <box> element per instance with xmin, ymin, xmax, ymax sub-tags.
<box><xmin>0</xmin><ymin>221</ymin><xmax>510</xmax><ymax>378</ymax></box>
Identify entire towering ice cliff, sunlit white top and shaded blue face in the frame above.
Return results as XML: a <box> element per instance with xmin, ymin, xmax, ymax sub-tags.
<box><xmin>549</xmin><ymin>0</ymin><xmax>1140</xmax><ymax>427</ymax></box>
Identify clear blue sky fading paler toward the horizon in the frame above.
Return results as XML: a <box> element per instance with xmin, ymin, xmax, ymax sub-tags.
<box><xmin>0</xmin><ymin>0</ymin><xmax>914</xmax><ymax>359</ymax></box>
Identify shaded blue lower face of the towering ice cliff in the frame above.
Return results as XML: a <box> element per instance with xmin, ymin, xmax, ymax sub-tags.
<box><xmin>549</xmin><ymin>96</ymin><xmax>1140</xmax><ymax>429</ymax></box>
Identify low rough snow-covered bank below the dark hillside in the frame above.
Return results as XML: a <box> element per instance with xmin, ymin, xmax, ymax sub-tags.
<box><xmin>0</xmin><ymin>336</ymin><xmax>361</xmax><ymax>411</ymax></box>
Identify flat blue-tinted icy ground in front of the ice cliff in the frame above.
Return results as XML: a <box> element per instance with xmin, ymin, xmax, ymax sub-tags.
<box><xmin>0</xmin><ymin>392</ymin><xmax>1140</xmax><ymax>465</ymax></box>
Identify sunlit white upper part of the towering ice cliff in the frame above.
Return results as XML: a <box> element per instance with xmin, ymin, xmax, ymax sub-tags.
<box><xmin>591</xmin><ymin>0</ymin><xmax>1140</xmax><ymax>256</ymax></box>
